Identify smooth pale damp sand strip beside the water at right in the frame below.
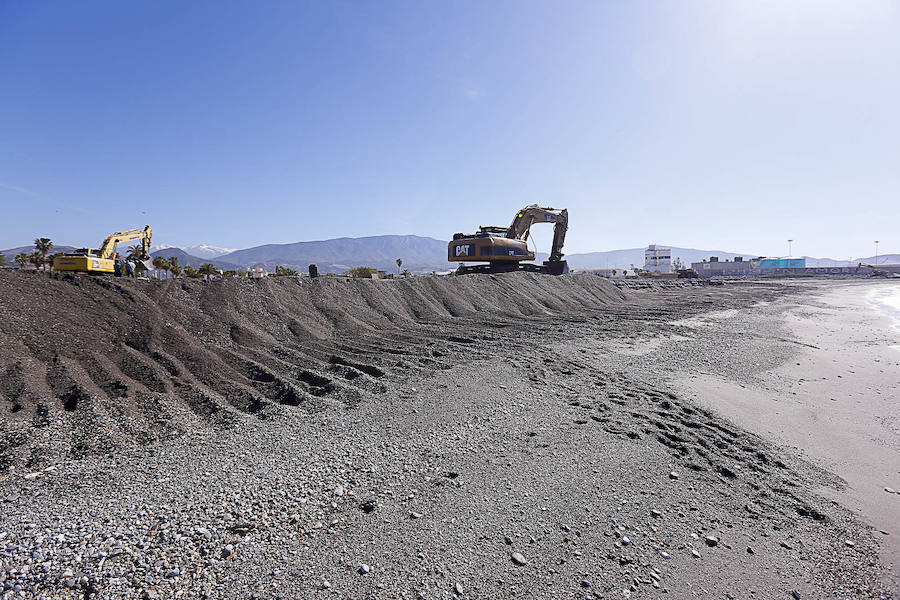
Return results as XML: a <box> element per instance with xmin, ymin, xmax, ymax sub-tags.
<box><xmin>676</xmin><ymin>283</ymin><xmax>900</xmax><ymax>590</ymax></box>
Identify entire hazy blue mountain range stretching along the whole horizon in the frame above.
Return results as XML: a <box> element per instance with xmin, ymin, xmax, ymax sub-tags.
<box><xmin>2</xmin><ymin>235</ymin><xmax>900</xmax><ymax>273</ymax></box>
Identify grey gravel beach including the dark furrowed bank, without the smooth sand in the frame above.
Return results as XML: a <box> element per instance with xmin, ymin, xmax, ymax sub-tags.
<box><xmin>0</xmin><ymin>271</ymin><xmax>900</xmax><ymax>599</ymax></box>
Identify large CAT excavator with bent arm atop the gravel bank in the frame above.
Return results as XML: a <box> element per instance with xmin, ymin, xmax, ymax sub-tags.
<box><xmin>447</xmin><ymin>204</ymin><xmax>569</xmax><ymax>275</ymax></box>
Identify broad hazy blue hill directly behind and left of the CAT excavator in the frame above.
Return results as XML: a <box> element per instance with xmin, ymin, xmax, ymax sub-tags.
<box><xmin>219</xmin><ymin>235</ymin><xmax>451</xmax><ymax>273</ymax></box>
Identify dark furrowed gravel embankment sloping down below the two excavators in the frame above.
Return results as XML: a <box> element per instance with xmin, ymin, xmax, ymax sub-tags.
<box><xmin>0</xmin><ymin>271</ymin><xmax>624</xmax><ymax>470</ymax></box>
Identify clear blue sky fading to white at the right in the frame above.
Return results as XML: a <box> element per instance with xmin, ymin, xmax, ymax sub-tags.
<box><xmin>0</xmin><ymin>0</ymin><xmax>900</xmax><ymax>258</ymax></box>
